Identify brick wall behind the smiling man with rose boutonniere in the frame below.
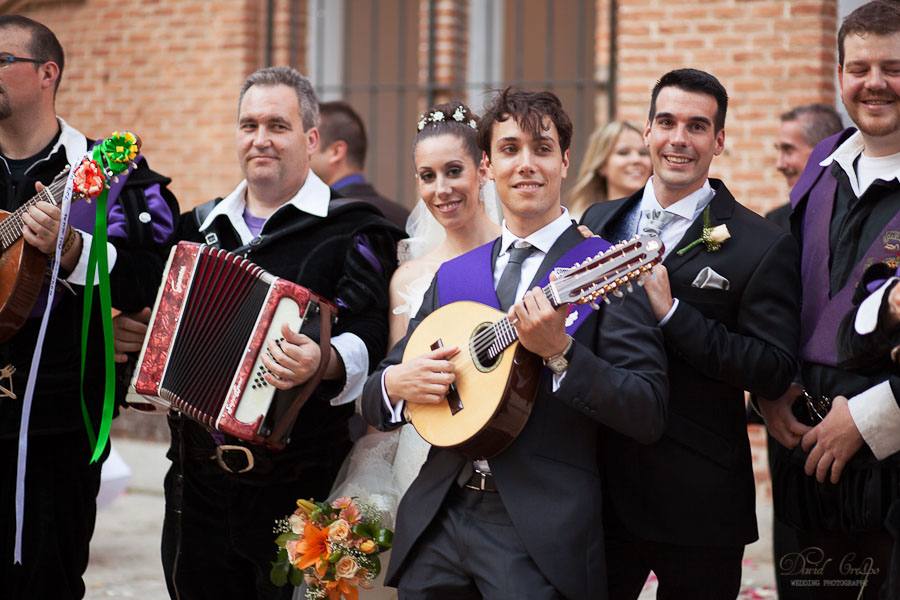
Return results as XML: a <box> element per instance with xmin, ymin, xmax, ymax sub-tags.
<box><xmin>617</xmin><ymin>0</ymin><xmax>837</xmax><ymax>211</ymax></box>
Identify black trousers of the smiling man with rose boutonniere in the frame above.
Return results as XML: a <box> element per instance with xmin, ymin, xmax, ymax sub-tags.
<box><xmin>606</xmin><ymin>528</ymin><xmax>744</xmax><ymax>600</ymax></box>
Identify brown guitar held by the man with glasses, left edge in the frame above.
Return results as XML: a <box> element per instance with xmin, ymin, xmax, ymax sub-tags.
<box><xmin>0</xmin><ymin>166</ymin><xmax>78</xmax><ymax>342</ymax></box>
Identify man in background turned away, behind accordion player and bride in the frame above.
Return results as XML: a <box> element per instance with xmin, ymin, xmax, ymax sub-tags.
<box><xmin>310</xmin><ymin>101</ymin><xmax>409</xmax><ymax>229</ymax></box>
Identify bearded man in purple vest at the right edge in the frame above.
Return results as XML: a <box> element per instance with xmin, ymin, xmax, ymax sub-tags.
<box><xmin>760</xmin><ymin>0</ymin><xmax>900</xmax><ymax>598</ymax></box>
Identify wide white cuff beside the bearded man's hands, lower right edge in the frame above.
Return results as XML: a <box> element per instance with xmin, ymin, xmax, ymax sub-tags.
<box><xmin>847</xmin><ymin>381</ymin><xmax>900</xmax><ymax>460</ymax></box>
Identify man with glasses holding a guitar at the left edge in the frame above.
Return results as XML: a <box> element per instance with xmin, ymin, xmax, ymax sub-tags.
<box><xmin>0</xmin><ymin>15</ymin><xmax>177</xmax><ymax>600</ymax></box>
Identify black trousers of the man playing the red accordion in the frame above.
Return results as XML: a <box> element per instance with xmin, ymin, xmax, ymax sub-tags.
<box><xmin>162</xmin><ymin>436</ymin><xmax>346</xmax><ymax>600</ymax></box>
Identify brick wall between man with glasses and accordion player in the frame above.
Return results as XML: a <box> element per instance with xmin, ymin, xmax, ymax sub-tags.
<box><xmin>21</xmin><ymin>0</ymin><xmax>283</xmax><ymax>208</ymax></box>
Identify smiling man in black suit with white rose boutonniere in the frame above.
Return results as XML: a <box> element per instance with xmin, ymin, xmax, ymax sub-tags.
<box><xmin>582</xmin><ymin>69</ymin><xmax>800</xmax><ymax>600</ymax></box>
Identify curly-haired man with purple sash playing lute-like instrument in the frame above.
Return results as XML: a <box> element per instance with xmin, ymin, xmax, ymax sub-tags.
<box><xmin>363</xmin><ymin>89</ymin><xmax>667</xmax><ymax>600</ymax></box>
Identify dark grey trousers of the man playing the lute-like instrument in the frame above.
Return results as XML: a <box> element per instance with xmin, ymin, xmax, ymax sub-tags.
<box><xmin>396</xmin><ymin>486</ymin><xmax>564</xmax><ymax>600</ymax></box>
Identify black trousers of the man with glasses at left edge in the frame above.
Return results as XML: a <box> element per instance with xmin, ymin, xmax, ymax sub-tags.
<box><xmin>0</xmin><ymin>431</ymin><xmax>109</xmax><ymax>600</ymax></box>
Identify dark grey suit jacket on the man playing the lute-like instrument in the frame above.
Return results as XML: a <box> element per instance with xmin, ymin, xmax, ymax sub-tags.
<box><xmin>363</xmin><ymin>225</ymin><xmax>667</xmax><ymax>599</ymax></box>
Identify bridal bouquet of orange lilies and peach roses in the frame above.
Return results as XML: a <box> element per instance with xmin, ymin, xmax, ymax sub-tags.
<box><xmin>269</xmin><ymin>498</ymin><xmax>394</xmax><ymax>600</ymax></box>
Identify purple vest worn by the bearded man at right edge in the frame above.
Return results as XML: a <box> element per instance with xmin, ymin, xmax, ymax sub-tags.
<box><xmin>791</xmin><ymin>129</ymin><xmax>900</xmax><ymax>367</ymax></box>
